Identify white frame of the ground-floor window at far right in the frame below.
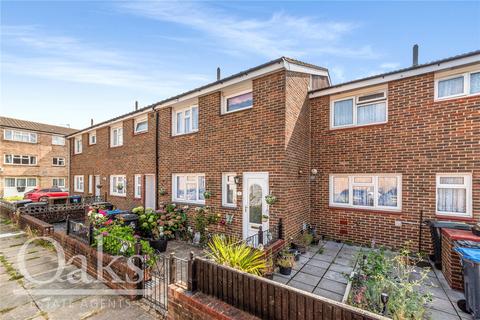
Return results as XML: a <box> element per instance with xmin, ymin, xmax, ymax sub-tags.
<box><xmin>435</xmin><ymin>173</ymin><xmax>473</xmax><ymax>218</ymax></box>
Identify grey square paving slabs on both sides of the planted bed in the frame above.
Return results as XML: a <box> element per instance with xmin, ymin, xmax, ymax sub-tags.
<box><xmin>273</xmin><ymin>241</ymin><xmax>473</xmax><ymax>320</ymax></box>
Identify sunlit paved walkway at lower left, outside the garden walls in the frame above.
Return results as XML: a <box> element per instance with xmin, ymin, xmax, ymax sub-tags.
<box><xmin>0</xmin><ymin>217</ymin><xmax>160</xmax><ymax>320</ymax></box>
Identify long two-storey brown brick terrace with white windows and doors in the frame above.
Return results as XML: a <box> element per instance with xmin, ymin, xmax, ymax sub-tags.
<box><xmin>65</xmin><ymin>51</ymin><xmax>480</xmax><ymax>248</ymax></box>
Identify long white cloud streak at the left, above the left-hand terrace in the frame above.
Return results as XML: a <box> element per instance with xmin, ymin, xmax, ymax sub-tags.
<box><xmin>1</xmin><ymin>26</ymin><xmax>208</xmax><ymax>96</ymax></box>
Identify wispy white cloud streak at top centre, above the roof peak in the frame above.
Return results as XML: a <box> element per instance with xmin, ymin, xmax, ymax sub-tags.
<box><xmin>118</xmin><ymin>1</ymin><xmax>376</xmax><ymax>58</ymax></box>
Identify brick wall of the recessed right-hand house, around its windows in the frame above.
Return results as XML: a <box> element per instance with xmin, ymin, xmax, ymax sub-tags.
<box><xmin>311</xmin><ymin>73</ymin><xmax>480</xmax><ymax>248</ymax></box>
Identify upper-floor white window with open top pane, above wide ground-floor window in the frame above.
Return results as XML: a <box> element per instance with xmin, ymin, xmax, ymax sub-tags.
<box><xmin>330</xmin><ymin>91</ymin><xmax>388</xmax><ymax>129</ymax></box>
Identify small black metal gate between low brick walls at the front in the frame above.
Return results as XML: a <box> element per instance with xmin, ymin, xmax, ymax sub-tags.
<box><xmin>143</xmin><ymin>255</ymin><xmax>170</xmax><ymax>311</ymax></box>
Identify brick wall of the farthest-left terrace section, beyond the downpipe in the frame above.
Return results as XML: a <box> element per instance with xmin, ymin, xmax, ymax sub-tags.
<box><xmin>70</xmin><ymin>113</ymin><xmax>155</xmax><ymax>209</ymax></box>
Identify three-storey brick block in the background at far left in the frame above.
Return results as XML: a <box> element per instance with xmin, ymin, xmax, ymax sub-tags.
<box><xmin>0</xmin><ymin>117</ymin><xmax>77</xmax><ymax>197</ymax></box>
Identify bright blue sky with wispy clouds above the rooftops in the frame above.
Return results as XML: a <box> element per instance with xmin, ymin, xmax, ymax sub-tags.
<box><xmin>0</xmin><ymin>1</ymin><xmax>480</xmax><ymax>128</ymax></box>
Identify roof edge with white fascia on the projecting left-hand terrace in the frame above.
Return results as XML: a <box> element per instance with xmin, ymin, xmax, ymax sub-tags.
<box><xmin>70</xmin><ymin>57</ymin><xmax>328</xmax><ymax>137</ymax></box>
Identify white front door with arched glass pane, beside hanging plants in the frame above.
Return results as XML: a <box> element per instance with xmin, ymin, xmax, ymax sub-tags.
<box><xmin>243</xmin><ymin>172</ymin><xmax>268</xmax><ymax>239</ymax></box>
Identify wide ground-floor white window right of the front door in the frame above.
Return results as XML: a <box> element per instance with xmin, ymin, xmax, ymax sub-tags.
<box><xmin>329</xmin><ymin>174</ymin><xmax>402</xmax><ymax>211</ymax></box>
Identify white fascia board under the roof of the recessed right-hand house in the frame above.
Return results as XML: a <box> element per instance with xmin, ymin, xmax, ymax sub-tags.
<box><xmin>309</xmin><ymin>54</ymin><xmax>480</xmax><ymax>98</ymax></box>
